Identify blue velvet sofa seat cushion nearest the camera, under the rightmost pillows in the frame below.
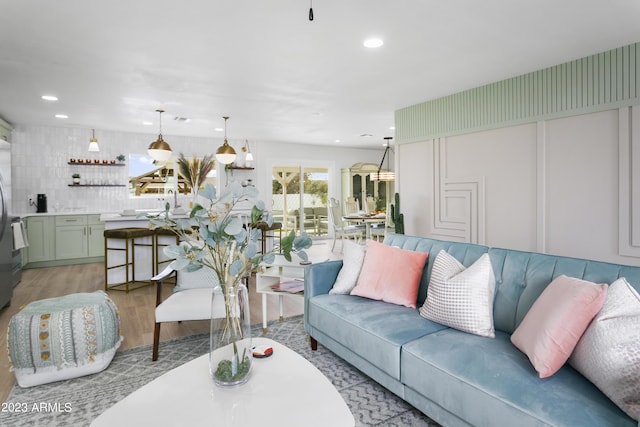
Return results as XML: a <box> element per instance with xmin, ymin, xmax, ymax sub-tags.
<box><xmin>402</xmin><ymin>329</ymin><xmax>637</xmax><ymax>427</ymax></box>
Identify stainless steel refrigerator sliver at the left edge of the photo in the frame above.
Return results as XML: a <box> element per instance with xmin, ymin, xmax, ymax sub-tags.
<box><xmin>0</xmin><ymin>140</ymin><xmax>14</xmax><ymax>309</ymax></box>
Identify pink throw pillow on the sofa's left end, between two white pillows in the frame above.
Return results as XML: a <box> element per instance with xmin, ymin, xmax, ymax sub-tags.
<box><xmin>351</xmin><ymin>240</ymin><xmax>429</xmax><ymax>308</ymax></box>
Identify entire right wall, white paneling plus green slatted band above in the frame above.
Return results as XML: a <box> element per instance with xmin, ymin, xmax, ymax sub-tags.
<box><xmin>395</xmin><ymin>43</ymin><xmax>640</xmax><ymax>265</ymax></box>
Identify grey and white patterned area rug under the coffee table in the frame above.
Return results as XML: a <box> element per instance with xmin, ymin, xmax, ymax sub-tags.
<box><xmin>0</xmin><ymin>316</ymin><xmax>438</xmax><ymax>427</ymax></box>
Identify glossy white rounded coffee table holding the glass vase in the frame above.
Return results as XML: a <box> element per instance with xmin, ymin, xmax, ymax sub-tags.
<box><xmin>91</xmin><ymin>338</ymin><xmax>355</xmax><ymax>427</ymax></box>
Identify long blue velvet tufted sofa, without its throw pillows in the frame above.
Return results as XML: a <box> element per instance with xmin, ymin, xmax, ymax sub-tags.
<box><xmin>304</xmin><ymin>234</ymin><xmax>640</xmax><ymax>427</ymax></box>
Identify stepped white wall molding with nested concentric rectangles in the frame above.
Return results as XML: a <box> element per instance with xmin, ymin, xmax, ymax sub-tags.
<box><xmin>431</xmin><ymin>138</ymin><xmax>485</xmax><ymax>244</ymax></box>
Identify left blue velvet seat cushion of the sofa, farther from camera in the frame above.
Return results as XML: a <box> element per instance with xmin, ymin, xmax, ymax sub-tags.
<box><xmin>305</xmin><ymin>295</ymin><xmax>446</xmax><ymax>380</ymax></box>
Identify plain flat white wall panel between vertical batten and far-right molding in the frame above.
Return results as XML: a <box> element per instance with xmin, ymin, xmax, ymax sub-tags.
<box><xmin>544</xmin><ymin>109</ymin><xmax>621</xmax><ymax>262</ymax></box>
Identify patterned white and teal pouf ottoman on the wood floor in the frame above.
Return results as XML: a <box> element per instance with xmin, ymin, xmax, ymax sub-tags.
<box><xmin>7</xmin><ymin>291</ymin><xmax>122</xmax><ymax>387</ymax></box>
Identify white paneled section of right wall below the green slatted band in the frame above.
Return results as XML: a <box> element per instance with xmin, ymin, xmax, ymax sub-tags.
<box><xmin>399</xmin><ymin>108</ymin><xmax>640</xmax><ymax>265</ymax></box>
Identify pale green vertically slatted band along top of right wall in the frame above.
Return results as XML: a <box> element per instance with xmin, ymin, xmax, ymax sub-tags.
<box><xmin>395</xmin><ymin>43</ymin><xmax>640</xmax><ymax>143</ymax></box>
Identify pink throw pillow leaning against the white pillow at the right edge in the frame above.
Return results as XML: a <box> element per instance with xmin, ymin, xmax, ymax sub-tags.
<box><xmin>511</xmin><ymin>275</ymin><xmax>607</xmax><ymax>378</ymax></box>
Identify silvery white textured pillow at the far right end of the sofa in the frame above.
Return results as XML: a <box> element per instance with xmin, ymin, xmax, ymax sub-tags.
<box><xmin>569</xmin><ymin>278</ymin><xmax>640</xmax><ymax>420</ymax></box>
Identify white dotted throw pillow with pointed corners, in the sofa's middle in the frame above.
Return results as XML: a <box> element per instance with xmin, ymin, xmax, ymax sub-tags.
<box><xmin>420</xmin><ymin>251</ymin><xmax>496</xmax><ymax>338</ymax></box>
